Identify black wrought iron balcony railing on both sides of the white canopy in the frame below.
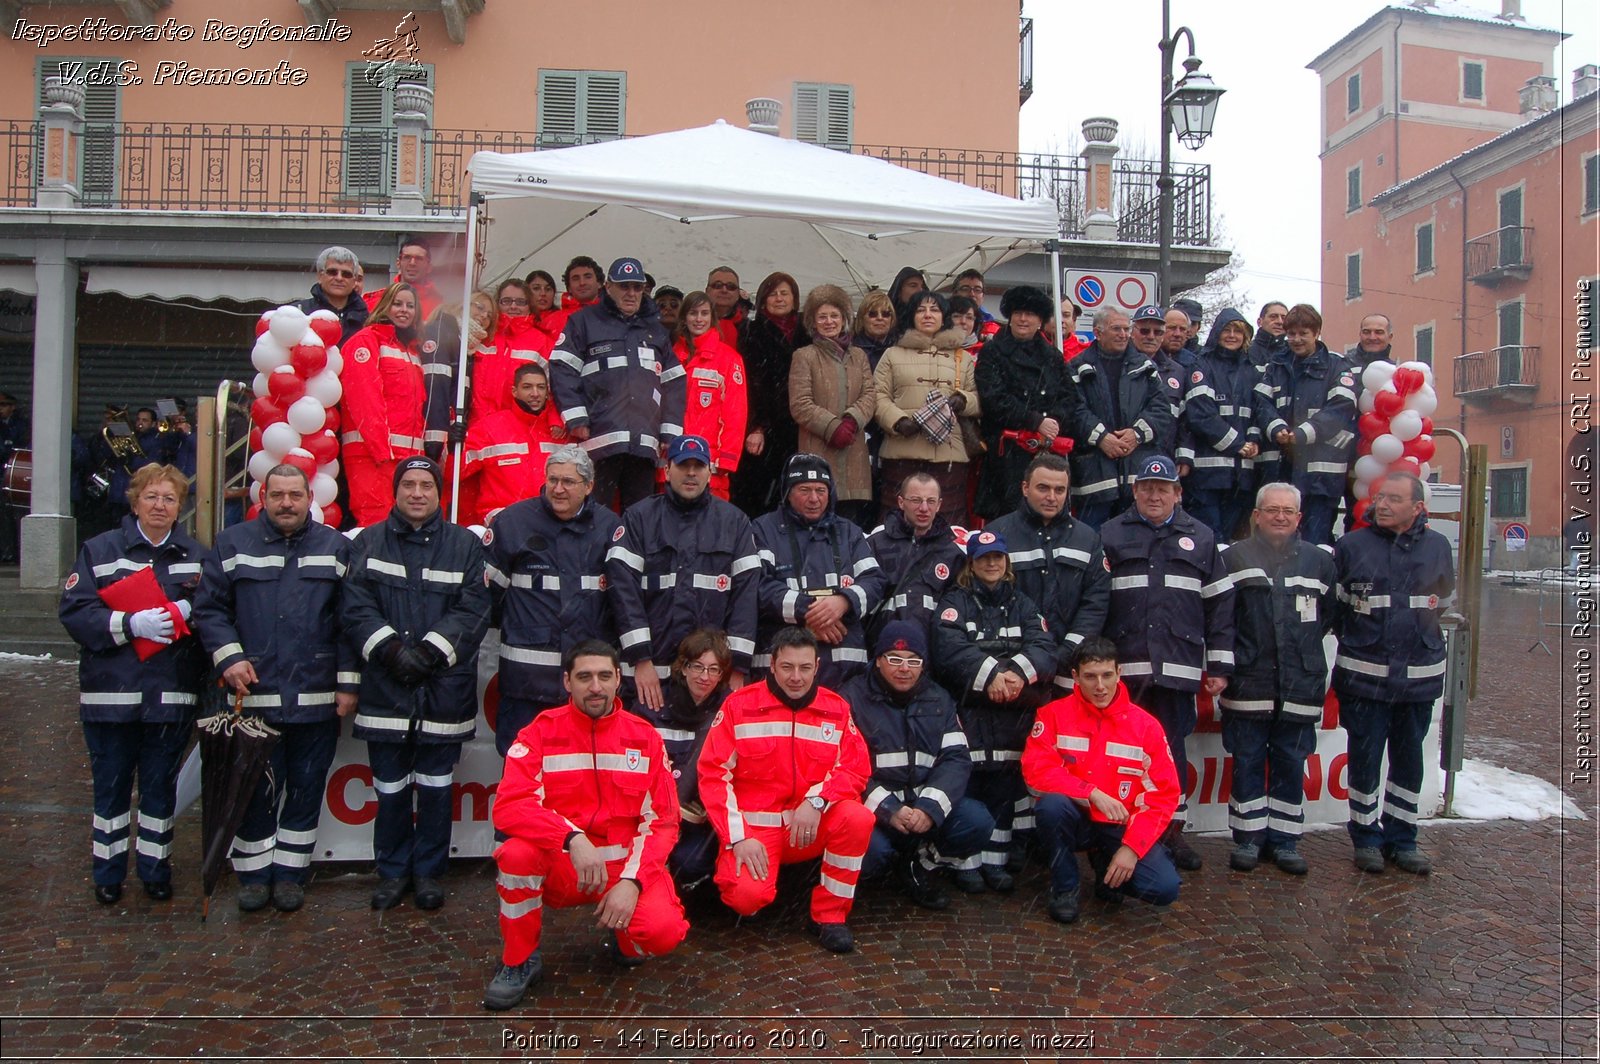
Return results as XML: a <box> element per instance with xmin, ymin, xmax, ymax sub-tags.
<box><xmin>0</xmin><ymin>122</ymin><xmax>1211</xmax><ymax>245</ymax></box>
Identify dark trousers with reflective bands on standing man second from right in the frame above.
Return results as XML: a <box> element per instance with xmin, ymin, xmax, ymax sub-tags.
<box><xmin>1222</xmin><ymin>710</ymin><xmax>1317</xmax><ymax>848</ymax></box>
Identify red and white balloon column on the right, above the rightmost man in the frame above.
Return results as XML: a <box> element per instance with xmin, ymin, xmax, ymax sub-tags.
<box><xmin>1352</xmin><ymin>362</ymin><xmax>1438</xmax><ymax>525</ymax></box>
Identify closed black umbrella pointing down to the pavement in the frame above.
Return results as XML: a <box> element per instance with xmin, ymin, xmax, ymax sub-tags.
<box><xmin>195</xmin><ymin>694</ymin><xmax>280</xmax><ymax>920</ymax></box>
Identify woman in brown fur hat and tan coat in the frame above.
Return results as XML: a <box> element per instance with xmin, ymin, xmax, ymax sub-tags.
<box><xmin>789</xmin><ymin>285</ymin><xmax>877</xmax><ymax>525</ymax></box>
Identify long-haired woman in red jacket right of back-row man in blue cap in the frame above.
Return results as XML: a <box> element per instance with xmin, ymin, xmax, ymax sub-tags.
<box><xmin>661</xmin><ymin>291</ymin><xmax>749</xmax><ymax>499</ymax></box>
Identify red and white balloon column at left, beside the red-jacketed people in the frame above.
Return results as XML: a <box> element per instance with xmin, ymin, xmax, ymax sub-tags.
<box><xmin>248</xmin><ymin>307</ymin><xmax>344</xmax><ymax>528</ymax></box>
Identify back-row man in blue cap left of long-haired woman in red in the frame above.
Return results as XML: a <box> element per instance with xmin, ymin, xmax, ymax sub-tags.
<box><xmin>550</xmin><ymin>258</ymin><xmax>688</xmax><ymax>512</ymax></box>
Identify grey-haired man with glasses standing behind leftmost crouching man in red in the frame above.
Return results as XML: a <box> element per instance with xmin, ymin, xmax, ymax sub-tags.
<box><xmin>483</xmin><ymin>443</ymin><xmax>638</xmax><ymax>757</ymax></box>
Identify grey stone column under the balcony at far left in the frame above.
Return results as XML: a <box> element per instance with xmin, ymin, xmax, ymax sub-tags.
<box><xmin>21</xmin><ymin>240</ymin><xmax>78</xmax><ymax>587</ymax></box>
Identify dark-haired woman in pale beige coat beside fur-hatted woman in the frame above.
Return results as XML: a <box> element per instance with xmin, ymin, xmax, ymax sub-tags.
<box><xmin>874</xmin><ymin>291</ymin><xmax>978</xmax><ymax>525</ymax></box>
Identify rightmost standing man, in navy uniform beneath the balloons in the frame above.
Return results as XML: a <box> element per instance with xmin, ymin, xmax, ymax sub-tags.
<box><xmin>1333</xmin><ymin>474</ymin><xmax>1456</xmax><ymax>875</ymax></box>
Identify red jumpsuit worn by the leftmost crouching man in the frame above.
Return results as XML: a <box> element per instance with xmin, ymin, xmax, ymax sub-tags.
<box><xmin>494</xmin><ymin>699</ymin><xmax>690</xmax><ymax>965</ymax></box>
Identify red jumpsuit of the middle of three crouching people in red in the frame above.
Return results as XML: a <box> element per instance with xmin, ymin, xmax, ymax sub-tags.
<box><xmin>698</xmin><ymin>683</ymin><xmax>874</xmax><ymax>923</ymax></box>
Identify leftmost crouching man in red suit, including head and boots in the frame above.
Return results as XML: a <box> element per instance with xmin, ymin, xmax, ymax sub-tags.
<box><xmin>483</xmin><ymin>640</ymin><xmax>690</xmax><ymax>1010</ymax></box>
